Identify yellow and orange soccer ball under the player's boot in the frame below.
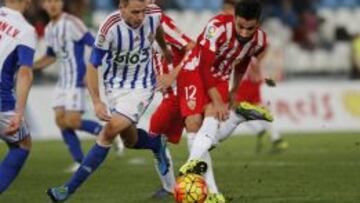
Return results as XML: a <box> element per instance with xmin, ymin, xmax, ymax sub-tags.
<box><xmin>174</xmin><ymin>174</ymin><xmax>208</xmax><ymax>203</ymax></box>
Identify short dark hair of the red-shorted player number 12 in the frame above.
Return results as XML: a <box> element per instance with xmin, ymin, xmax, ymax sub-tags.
<box><xmin>235</xmin><ymin>0</ymin><xmax>262</xmax><ymax>20</ymax></box>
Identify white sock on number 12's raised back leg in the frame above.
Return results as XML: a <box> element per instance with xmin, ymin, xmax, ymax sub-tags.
<box><xmin>214</xmin><ymin>111</ymin><xmax>246</xmax><ymax>144</ymax></box>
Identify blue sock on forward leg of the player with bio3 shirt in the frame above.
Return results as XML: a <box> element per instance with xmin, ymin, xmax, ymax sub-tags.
<box><xmin>65</xmin><ymin>143</ymin><xmax>111</xmax><ymax>194</ymax></box>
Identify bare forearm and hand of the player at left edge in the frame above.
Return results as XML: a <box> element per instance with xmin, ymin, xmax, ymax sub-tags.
<box><xmin>5</xmin><ymin>66</ymin><xmax>33</xmax><ymax>135</ymax></box>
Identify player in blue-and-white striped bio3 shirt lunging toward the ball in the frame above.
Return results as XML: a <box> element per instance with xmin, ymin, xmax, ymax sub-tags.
<box><xmin>47</xmin><ymin>0</ymin><xmax>171</xmax><ymax>202</ymax></box>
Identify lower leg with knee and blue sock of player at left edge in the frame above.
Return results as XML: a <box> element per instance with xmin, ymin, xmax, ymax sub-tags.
<box><xmin>0</xmin><ymin>136</ymin><xmax>31</xmax><ymax>194</ymax></box>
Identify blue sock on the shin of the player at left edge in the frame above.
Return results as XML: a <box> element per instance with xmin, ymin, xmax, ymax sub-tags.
<box><xmin>0</xmin><ymin>147</ymin><xmax>29</xmax><ymax>194</ymax></box>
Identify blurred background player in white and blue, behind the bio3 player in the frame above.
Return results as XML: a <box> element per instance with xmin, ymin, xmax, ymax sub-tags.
<box><xmin>34</xmin><ymin>0</ymin><xmax>102</xmax><ymax>172</ymax></box>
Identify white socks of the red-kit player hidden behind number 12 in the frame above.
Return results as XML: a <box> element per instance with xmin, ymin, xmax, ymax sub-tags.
<box><xmin>187</xmin><ymin>133</ymin><xmax>219</xmax><ymax>194</ymax></box>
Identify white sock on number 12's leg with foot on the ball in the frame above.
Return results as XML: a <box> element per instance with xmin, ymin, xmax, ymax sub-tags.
<box><xmin>189</xmin><ymin>117</ymin><xmax>219</xmax><ymax>160</ymax></box>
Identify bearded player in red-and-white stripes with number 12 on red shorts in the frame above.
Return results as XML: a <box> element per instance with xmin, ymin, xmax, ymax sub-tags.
<box><xmin>158</xmin><ymin>0</ymin><xmax>270</xmax><ymax>174</ymax></box>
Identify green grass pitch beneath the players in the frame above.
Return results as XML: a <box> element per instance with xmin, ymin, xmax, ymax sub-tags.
<box><xmin>0</xmin><ymin>133</ymin><xmax>360</xmax><ymax>203</ymax></box>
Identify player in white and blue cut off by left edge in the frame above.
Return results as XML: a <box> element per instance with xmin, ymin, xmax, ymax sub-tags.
<box><xmin>0</xmin><ymin>0</ymin><xmax>36</xmax><ymax>194</ymax></box>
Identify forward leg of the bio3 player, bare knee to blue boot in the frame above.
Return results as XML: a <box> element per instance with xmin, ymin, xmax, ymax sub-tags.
<box><xmin>47</xmin><ymin>115</ymin><xmax>131</xmax><ymax>202</ymax></box>
